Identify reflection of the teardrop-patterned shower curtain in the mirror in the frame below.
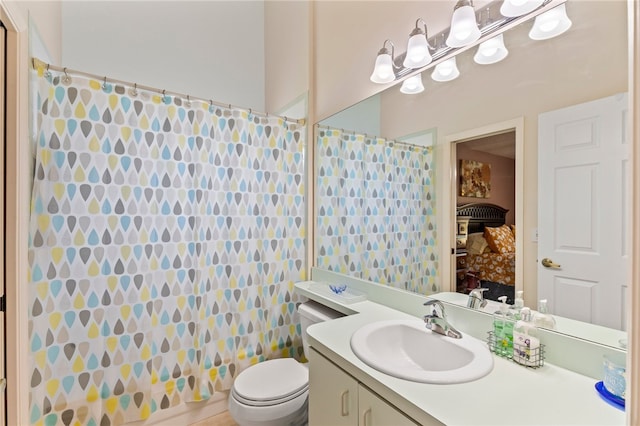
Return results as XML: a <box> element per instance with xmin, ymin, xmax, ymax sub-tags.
<box><xmin>316</xmin><ymin>128</ymin><xmax>439</xmax><ymax>294</ymax></box>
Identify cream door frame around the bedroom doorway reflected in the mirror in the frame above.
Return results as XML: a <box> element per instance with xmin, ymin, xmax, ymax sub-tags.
<box><xmin>443</xmin><ymin>117</ymin><xmax>525</xmax><ymax>292</ymax></box>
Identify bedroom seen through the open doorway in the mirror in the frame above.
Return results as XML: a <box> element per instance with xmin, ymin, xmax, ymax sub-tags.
<box><xmin>456</xmin><ymin>132</ymin><xmax>516</xmax><ymax>303</ymax></box>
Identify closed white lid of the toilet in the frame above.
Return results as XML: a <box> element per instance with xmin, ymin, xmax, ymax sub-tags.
<box><xmin>233</xmin><ymin>358</ymin><xmax>309</xmax><ymax>405</ymax></box>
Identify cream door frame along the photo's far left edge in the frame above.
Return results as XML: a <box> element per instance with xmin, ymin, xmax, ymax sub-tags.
<box><xmin>0</xmin><ymin>2</ymin><xmax>30</xmax><ymax>425</ymax></box>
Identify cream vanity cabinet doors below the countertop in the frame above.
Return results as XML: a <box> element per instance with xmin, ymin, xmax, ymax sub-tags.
<box><xmin>309</xmin><ymin>348</ymin><xmax>418</xmax><ymax>426</ymax></box>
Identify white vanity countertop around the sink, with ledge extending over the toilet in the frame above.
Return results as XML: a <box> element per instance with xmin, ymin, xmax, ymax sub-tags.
<box><xmin>296</xmin><ymin>281</ymin><xmax>625</xmax><ymax>426</ymax></box>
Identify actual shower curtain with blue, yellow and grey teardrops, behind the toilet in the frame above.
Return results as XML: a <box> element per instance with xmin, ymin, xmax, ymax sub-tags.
<box><xmin>29</xmin><ymin>69</ymin><xmax>306</xmax><ymax>425</ymax></box>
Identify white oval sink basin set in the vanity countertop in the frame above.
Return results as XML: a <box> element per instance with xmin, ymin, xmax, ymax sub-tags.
<box><xmin>351</xmin><ymin>320</ymin><xmax>493</xmax><ymax>384</ymax></box>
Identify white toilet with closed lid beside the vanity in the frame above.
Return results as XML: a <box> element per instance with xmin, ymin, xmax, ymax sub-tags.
<box><xmin>229</xmin><ymin>300</ymin><xmax>344</xmax><ymax>426</ymax></box>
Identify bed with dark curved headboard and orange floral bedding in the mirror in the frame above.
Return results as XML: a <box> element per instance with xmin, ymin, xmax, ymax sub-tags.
<box><xmin>456</xmin><ymin>203</ymin><xmax>516</xmax><ymax>304</ymax></box>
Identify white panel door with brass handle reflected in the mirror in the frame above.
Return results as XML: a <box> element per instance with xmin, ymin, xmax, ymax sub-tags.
<box><xmin>538</xmin><ymin>94</ymin><xmax>631</xmax><ymax>329</ymax></box>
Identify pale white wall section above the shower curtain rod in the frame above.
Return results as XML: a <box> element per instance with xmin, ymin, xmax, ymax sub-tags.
<box><xmin>62</xmin><ymin>0</ymin><xmax>265</xmax><ymax>111</ymax></box>
